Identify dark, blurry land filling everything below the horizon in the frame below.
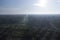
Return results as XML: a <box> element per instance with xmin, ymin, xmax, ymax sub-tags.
<box><xmin>0</xmin><ymin>15</ymin><xmax>60</xmax><ymax>40</ymax></box>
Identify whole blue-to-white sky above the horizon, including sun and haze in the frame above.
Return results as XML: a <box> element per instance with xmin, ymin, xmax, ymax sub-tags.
<box><xmin>0</xmin><ymin>0</ymin><xmax>60</xmax><ymax>14</ymax></box>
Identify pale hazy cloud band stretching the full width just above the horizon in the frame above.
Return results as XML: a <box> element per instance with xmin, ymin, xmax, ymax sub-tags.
<box><xmin>0</xmin><ymin>8</ymin><xmax>60</xmax><ymax>14</ymax></box>
